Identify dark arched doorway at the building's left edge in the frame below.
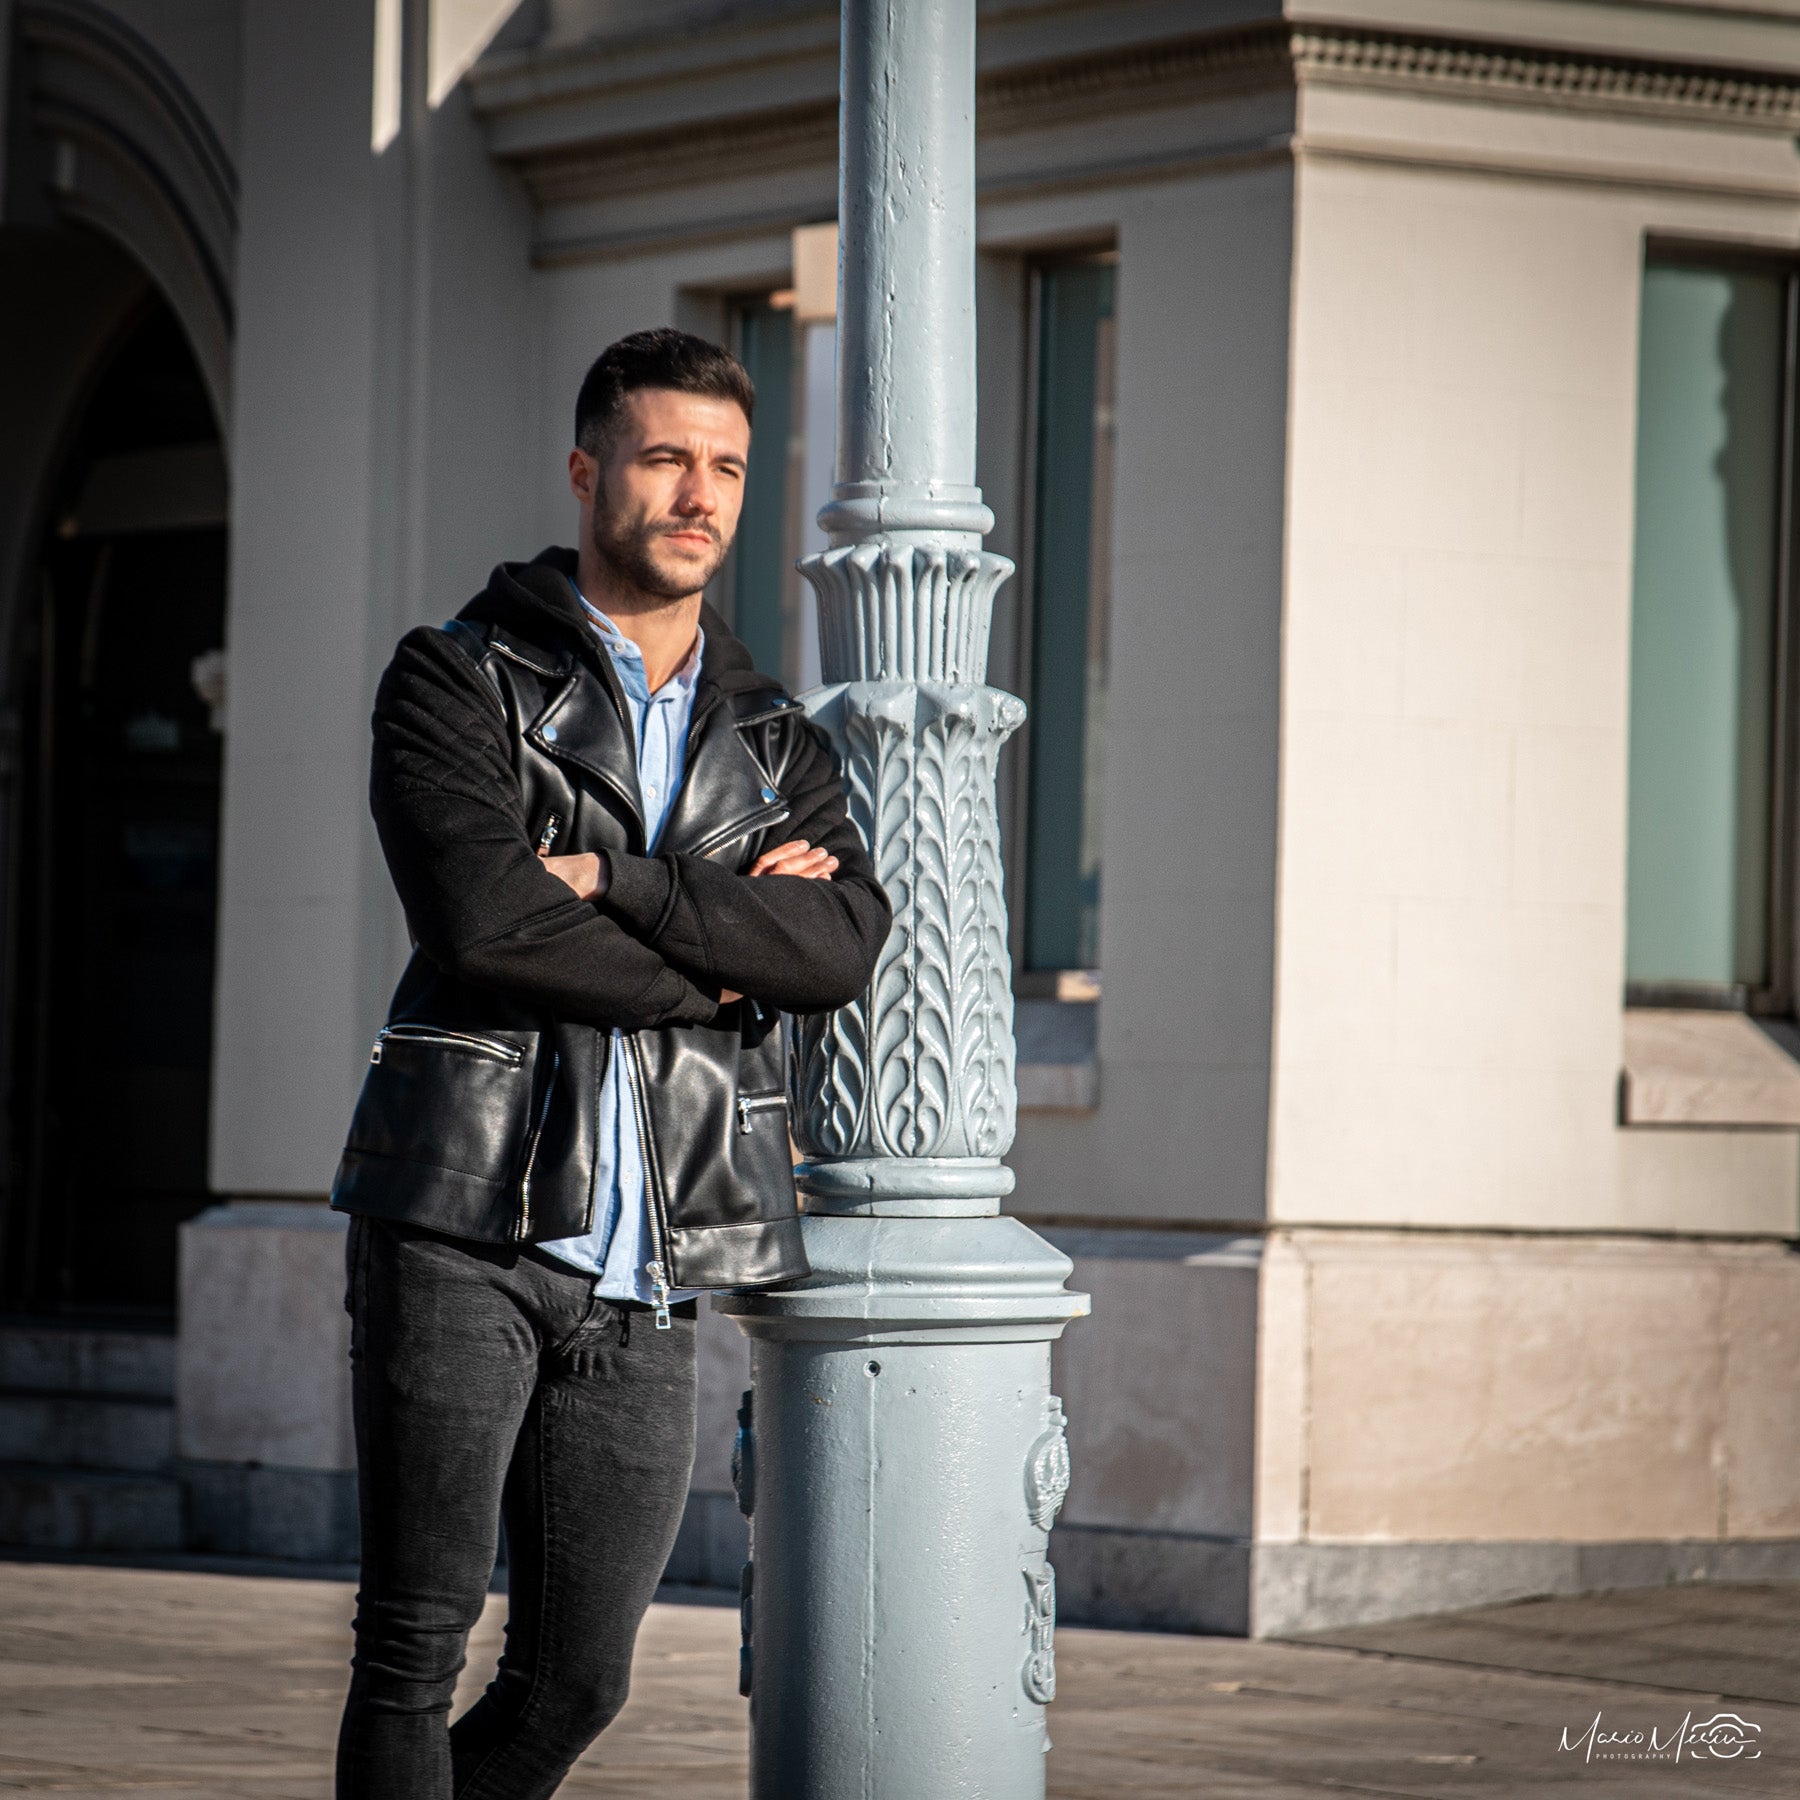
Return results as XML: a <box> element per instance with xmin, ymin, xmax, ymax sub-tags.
<box><xmin>0</xmin><ymin>297</ymin><xmax>227</xmax><ymax>1312</ymax></box>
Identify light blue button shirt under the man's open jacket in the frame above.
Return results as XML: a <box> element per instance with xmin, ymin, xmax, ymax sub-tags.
<box><xmin>538</xmin><ymin>594</ymin><xmax>706</xmax><ymax>1305</ymax></box>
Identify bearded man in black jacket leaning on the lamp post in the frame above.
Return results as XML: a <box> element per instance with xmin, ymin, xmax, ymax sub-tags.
<box><xmin>333</xmin><ymin>331</ymin><xmax>889</xmax><ymax>1800</ymax></box>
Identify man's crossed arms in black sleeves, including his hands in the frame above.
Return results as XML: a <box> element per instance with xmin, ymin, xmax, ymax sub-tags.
<box><xmin>369</xmin><ymin>630</ymin><xmax>891</xmax><ymax>1031</ymax></box>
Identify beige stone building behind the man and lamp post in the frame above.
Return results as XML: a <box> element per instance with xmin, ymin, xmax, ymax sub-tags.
<box><xmin>0</xmin><ymin>0</ymin><xmax>1800</xmax><ymax>1633</ymax></box>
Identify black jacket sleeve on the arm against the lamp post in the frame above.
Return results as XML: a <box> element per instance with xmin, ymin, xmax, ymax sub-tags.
<box><xmin>599</xmin><ymin>722</ymin><xmax>893</xmax><ymax>1013</ymax></box>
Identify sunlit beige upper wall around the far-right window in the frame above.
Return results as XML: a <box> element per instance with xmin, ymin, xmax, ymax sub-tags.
<box><xmin>1269</xmin><ymin>88</ymin><xmax>1800</xmax><ymax>1231</ymax></box>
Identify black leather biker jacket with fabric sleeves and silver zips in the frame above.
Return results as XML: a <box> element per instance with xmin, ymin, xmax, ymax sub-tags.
<box><xmin>331</xmin><ymin>551</ymin><xmax>891</xmax><ymax>1289</ymax></box>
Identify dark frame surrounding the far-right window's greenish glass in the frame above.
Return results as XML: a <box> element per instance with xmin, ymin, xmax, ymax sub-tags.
<box><xmin>1624</xmin><ymin>236</ymin><xmax>1800</xmax><ymax>1017</ymax></box>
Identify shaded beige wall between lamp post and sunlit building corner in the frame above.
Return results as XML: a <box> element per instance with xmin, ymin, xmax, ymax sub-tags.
<box><xmin>1010</xmin><ymin>167</ymin><xmax>1292</xmax><ymax>1224</ymax></box>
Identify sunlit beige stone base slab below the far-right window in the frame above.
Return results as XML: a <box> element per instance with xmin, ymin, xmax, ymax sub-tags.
<box><xmin>1256</xmin><ymin>1231</ymin><xmax>1800</xmax><ymax>1544</ymax></box>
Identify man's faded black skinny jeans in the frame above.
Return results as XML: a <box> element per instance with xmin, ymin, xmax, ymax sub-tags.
<box><xmin>337</xmin><ymin>1217</ymin><xmax>695</xmax><ymax>1800</ymax></box>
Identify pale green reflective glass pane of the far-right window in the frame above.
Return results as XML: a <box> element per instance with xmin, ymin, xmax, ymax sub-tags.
<box><xmin>1625</xmin><ymin>265</ymin><xmax>1786</xmax><ymax>988</ymax></box>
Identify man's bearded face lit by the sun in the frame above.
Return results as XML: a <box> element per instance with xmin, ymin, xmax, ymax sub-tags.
<box><xmin>569</xmin><ymin>387</ymin><xmax>751</xmax><ymax>601</ymax></box>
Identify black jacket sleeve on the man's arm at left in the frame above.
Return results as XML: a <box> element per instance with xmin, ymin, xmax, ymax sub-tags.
<box><xmin>369</xmin><ymin>628</ymin><xmax>718</xmax><ymax>1031</ymax></box>
